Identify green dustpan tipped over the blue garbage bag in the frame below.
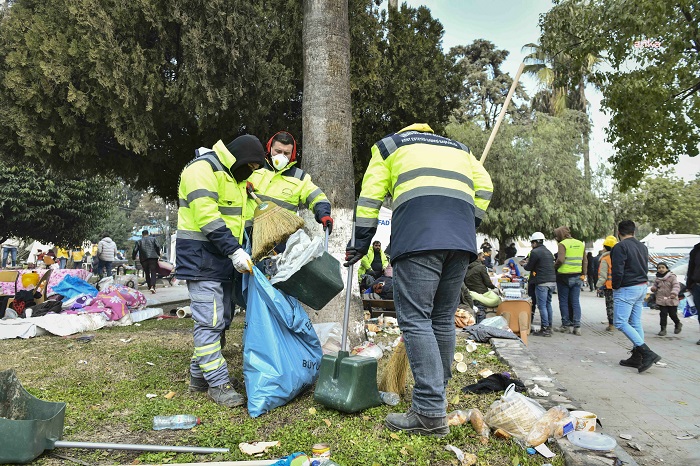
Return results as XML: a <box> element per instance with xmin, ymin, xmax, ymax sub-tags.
<box><xmin>273</xmin><ymin>251</ymin><xmax>343</xmax><ymax>311</ymax></box>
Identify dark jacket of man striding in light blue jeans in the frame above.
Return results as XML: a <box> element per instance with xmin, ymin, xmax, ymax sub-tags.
<box><xmin>610</xmin><ymin>237</ymin><xmax>649</xmax><ymax>290</ymax></box>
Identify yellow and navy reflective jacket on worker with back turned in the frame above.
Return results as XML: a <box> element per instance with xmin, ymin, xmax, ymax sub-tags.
<box><xmin>355</xmin><ymin>124</ymin><xmax>493</xmax><ymax>262</ymax></box>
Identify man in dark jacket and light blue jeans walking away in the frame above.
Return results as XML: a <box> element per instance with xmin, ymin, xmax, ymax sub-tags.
<box><xmin>610</xmin><ymin>220</ymin><xmax>661</xmax><ymax>373</ymax></box>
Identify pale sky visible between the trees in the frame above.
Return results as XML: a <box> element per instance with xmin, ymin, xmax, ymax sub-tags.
<box><xmin>400</xmin><ymin>0</ymin><xmax>700</xmax><ymax>181</ymax></box>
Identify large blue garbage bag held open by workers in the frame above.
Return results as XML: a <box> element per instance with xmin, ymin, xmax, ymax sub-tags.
<box><xmin>243</xmin><ymin>267</ymin><xmax>323</xmax><ymax>417</ymax></box>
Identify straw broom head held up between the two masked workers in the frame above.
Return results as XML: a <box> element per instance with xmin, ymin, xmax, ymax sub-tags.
<box><xmin>246</xmin><ymin>185</ymin><xmax>304</xmax><ymax>259</ymax></box>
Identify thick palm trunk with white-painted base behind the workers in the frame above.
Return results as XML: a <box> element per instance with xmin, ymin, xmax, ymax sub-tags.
<box><xmin>302</xmin><ymin>0</ymin><xmax>362</xmax><ymax>330</ymax></box>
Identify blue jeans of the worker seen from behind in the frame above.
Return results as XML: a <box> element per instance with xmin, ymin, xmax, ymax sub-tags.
<box><xmin>393</xmin><ymin>250</ymin><xmax>469</xmax><ymax>417</ymax></box>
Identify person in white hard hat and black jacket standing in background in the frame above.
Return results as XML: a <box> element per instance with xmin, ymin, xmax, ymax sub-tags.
<box><xmin>523</xmin><ymin>231</ymin><xmax>557</xmax><ymax>337</ymax></box>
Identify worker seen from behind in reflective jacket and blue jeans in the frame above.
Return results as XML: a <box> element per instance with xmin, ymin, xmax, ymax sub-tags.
<box><xmin>345</xmin><ymin>124</ymin><xmax>493</xmax><ymax>436</ymax></box>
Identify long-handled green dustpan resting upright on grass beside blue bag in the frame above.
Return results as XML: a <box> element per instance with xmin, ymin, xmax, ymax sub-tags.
<box><xmin>314</xmin><ymin>215</ymin><xmax>382</xmax><ymax>413</ymax></box>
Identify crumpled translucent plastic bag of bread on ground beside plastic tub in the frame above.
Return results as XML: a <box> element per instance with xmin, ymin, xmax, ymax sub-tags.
<box><xmin>485</xmin><ymin>384</ymin><xmax>545</xmax><ymax>440</ymax></box>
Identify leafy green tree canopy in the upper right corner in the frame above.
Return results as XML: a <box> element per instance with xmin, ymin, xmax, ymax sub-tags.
<box><xmin>540</xmin><ymin>0</ymin><xmax>700</xmax><ymax>190</ymax></box>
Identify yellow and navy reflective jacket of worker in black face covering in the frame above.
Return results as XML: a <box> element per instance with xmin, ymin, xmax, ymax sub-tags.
<box><xmin>175</xmin><ymin>141</ymin><xmax>252</xmax><ymax>282</ymax></box>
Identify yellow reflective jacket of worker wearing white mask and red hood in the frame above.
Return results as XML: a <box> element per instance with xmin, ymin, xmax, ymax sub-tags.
<box><xmin>248</xmin><ymin>162</ymin><xmax>331</xmax><ymax>223</ymax></box>
